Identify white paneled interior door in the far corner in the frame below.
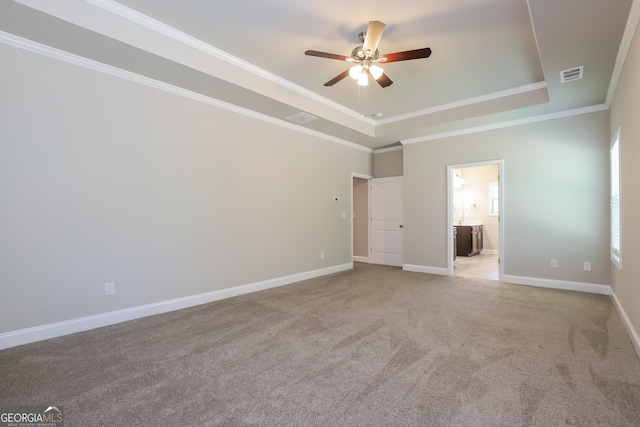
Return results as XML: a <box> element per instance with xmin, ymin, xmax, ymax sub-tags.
<box><xmin>371</xmin><ymin>176</ymin><xmax>402</xmax><ymax>267</ymax></box>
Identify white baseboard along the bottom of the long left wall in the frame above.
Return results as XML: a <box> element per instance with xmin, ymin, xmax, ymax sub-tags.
<box><xmin>0</xmin><ymin>262</ymin><xmax>353</xmax><ymax>350</ymax></box>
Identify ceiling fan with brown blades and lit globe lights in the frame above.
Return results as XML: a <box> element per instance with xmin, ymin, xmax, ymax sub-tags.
<box><xmin>304</xmin><ymin>21</ymin><xmax>431</xmax><ymax>87</ymax></box>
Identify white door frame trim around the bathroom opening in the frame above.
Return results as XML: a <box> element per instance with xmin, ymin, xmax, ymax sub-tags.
<box><xmin>446</xmin><ymin>159</ymin><xmax>506</xmax><ymax>281</ymax></box>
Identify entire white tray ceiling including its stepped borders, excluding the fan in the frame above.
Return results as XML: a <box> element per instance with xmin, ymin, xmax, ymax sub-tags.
<box><xmin>0</xmin><ymin>0</ymin><xmax>635</xmax><ymax>149</ymax></box>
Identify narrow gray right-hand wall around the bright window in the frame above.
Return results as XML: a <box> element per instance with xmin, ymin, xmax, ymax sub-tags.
<box><xmin>608</xmin><ymin>19</ymin><xmax>640</xmax><ymax>355</ymax></box>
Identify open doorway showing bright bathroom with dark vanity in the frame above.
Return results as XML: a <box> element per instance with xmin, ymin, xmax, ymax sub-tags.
<box><xmin>447</xmin><ymin>160</ymin><xmax>504</xmax><ymax>280</ymax></box>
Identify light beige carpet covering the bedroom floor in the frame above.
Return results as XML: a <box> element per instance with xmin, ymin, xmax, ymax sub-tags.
<box><xmin>0</xmin><ymin>264</ymin><xmax>640</xmax><ymax>426</ymax></box>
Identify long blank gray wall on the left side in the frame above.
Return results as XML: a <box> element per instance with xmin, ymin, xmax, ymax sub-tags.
<box><xmin>0</xmin><ymin>45</ymin><xmax>372</xmax><ymax>333</ymax></box>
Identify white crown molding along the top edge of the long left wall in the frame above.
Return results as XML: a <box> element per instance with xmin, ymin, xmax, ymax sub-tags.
<box><xmin>0</xmin><ymin>31</ymin><xmax>373</xmax><ymax>153</ymax></box>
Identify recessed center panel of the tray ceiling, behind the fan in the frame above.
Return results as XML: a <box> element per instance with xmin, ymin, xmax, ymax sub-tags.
<box><xmin>114</xmin><ymin>0</ymin><xmax>544</xmax><ymax>118</ymax></box>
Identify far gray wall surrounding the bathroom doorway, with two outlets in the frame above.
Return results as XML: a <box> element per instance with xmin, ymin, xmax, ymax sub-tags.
<box><xmin>404</xmin><ymin>111</ymin><xmax>610</xmax><ymax>284</ymax></box>
